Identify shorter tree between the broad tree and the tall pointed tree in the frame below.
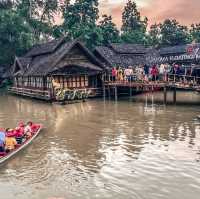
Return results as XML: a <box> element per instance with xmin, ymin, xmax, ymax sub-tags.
<box><xmin>99</xmin><ymin>15</ymin><xmax>119</xmax><ymax>45</ymax></box>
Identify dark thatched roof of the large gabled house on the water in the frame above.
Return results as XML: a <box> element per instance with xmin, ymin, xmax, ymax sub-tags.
<box><xmin>13</xmin><ymin>39</ymin><xmax>103</xmax><ymax>76</ymax></box>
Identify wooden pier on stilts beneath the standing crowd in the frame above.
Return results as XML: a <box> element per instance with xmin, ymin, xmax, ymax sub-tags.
<box><xmin>103</xmin><ymin>75</ymin><xmax>200</xmax><ymax>104</ymax></box>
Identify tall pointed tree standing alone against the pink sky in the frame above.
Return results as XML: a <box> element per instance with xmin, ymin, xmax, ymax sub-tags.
<box><xmin>121</xmin><ymin>0</ymin><xmax>148</xmax><ymax>44</ymax></box>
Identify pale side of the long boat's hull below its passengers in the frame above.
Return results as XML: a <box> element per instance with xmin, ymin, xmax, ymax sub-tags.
<box><xmin>0</xmin><ymin>125</ymin><xmax>42</xmax><ymax>164</ymax></box>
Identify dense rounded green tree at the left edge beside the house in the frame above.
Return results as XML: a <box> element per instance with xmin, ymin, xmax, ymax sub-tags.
<box><xmin>0</xmin><ymin>9</ymin><xmax>33</xmax><ymax>65</ymax></box>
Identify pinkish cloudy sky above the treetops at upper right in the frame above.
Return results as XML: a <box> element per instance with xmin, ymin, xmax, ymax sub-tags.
<box><xmin>99</xmin><ymin>0</ymin><xmax>200</xmax><ymax>27</ymax></box>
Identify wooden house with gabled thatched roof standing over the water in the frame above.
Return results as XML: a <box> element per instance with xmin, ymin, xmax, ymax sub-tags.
<box><xmin>10</xmin><ymin>38</ymin><xmax>103</xmax><ymax>100</ymax></box>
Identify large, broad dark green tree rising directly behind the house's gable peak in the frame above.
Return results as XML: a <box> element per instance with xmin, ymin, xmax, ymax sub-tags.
<box><xmin>60</xmin><ymin>0</ymin><xmax>102</xmax><ymax>48</ymax></box>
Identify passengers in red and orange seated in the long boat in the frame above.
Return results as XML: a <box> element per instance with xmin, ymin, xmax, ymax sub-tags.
<box><xmin>0</xmin><ymin>122</ymin><xmax>40</xmax><ymax>154</ymax></box>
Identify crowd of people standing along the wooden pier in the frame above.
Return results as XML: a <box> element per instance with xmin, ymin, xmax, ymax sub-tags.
<box><xmin>111</xmin><ymin>64</ymin><xmax>196</xmax><ymax>82</ymax></box>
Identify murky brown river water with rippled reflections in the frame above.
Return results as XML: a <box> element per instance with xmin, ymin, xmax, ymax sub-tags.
<box><xmin>0</xmin><ymin>93</ymin><xmax>200</xmax><ymax>199</ymax></box>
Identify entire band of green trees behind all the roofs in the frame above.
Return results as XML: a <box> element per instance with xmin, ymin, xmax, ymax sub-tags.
<box><xmin>0</xmin><ymin>0</ymin><xmax>200</xmax><ymax>65</ymax></box>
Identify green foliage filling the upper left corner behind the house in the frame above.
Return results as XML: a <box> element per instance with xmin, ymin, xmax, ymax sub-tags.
<box><xmin>0</xmin><ymin>0</ymin><xmax>58</xmax><ymax>65</ymax></box>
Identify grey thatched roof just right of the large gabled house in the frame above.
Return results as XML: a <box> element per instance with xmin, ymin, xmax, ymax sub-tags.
<box><xmin>94</xmin><ymin>44</ymin><xmax>147</xmax><ymax>67</ymax></box>
